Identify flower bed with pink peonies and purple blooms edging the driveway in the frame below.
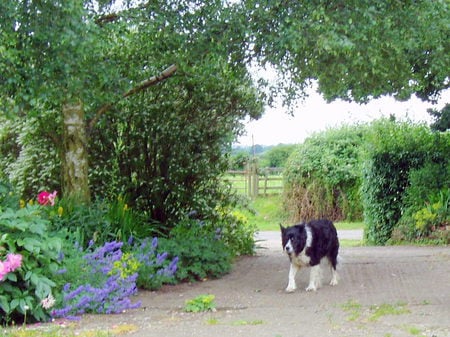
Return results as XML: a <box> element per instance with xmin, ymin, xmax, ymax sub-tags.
<box><xmin>0</xmin><ymin>184</ymin><xmax>256</xmax><ymax>324</ymax></box>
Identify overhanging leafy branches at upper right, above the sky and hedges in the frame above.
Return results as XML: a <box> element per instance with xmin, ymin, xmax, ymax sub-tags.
<box><xmin>243</xmin><ymin>0</ymin><xmax>450</xmax><ymax>102</ymax></box>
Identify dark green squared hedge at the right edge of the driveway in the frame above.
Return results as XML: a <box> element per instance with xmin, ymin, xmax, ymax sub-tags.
<box><xmin>362</xmin><ymin>120</ymin><xmax>450</xmax><ymax>244</ymax></box>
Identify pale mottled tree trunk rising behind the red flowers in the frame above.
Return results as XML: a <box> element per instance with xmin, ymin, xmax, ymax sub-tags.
<box><xmin>62</xmin><ymin>100</ymin><xmax>90</xmax><ymax>203</ymax></box>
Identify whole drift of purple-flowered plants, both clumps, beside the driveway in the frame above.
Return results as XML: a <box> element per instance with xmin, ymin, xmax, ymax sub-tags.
<box><xmin>51</xmin><ymin>238</ymin><xmax>177</xmax><ymax>318</ymax></box>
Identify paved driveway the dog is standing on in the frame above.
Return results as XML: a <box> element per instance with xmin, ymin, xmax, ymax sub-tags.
<box><xmin>48</xmin><ymin>234</ymin><xmax>450</xmax><ymax>337</ymax></box>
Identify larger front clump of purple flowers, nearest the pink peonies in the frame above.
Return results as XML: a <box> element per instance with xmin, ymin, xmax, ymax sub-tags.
<box><xmin>51</xmin><ymin>242</ymin><xmax>140</xmax><ymax>318</ymax></box>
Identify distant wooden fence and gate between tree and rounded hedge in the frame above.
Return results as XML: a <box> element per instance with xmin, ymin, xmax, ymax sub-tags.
<box><xmin>225</xmin><ymin>165</ymin><xmax>283</xmax><ymax>198</ymax></box>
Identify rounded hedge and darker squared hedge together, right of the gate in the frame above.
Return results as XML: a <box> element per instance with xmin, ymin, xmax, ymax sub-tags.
<box><xmin>285</xmin><ymin>119</ymin><xmax>450</xmax><ymax>245</ymax></box>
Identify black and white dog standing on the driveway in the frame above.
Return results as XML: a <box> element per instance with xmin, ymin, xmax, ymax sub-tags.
<box><xmin>280</xmin><ymin>219</ymin><xmax>339</xmax><ymax>292</ymax></box>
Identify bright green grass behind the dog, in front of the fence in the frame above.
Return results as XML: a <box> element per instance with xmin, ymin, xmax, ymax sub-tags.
<box><xmin>244</xmin><ymin>194</ymin><xmax>364</xmax><ymax>231</ymax></box>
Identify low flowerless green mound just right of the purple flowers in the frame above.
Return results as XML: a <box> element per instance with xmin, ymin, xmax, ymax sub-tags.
<box><xmin>158</xmin><ymin>220</ymin><xmax>233</xmax><ymax>282</ymax></box>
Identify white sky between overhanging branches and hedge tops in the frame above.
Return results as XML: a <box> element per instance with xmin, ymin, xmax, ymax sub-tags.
<box><xmin>235</xmin><ymin>82</ymin><xmax>450</xmax><ymax>146</ymax></box>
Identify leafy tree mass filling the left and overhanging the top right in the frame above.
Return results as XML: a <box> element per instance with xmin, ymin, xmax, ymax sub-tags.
<box><xmin>0</xmin><ymin>0</ymin><xmax>450</xmax><ymax>226</ymax></box>
